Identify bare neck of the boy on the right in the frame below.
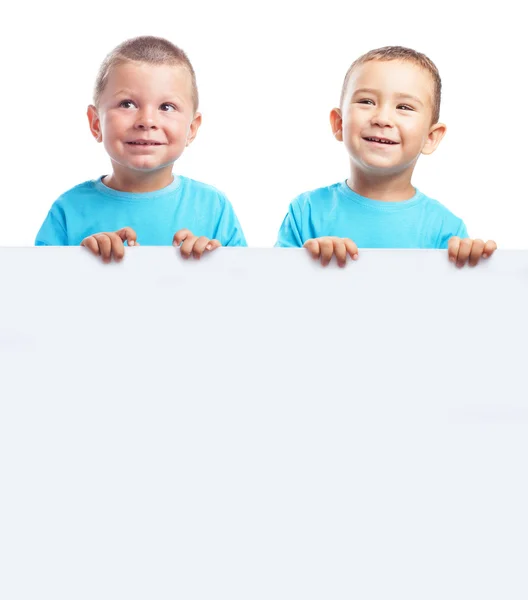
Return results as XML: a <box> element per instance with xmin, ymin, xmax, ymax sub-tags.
<box><xmin>347</xmin><ymin>169</ymin><xmax>416</xmax><ymax>202</ymax></box>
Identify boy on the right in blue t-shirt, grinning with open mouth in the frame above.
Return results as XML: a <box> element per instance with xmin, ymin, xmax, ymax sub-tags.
<box><xmin>276</xmin><ymin>46</ymin><xmax>497</xmax><ymax>266</ymax></box>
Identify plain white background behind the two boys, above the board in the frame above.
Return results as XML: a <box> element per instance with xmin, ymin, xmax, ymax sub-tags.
<box><xmin>0</xmin><ymin>0</ymin><xmax>528</xmax><ymax>248</ymax></box>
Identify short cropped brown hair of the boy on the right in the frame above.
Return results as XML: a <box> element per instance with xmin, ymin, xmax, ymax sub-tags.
<box><xmin>340</xmin><ymin>46</ymin><xmax>442</xmax><ymax>123</ymax></box>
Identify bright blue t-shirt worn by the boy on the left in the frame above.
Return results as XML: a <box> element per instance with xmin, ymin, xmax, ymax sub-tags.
<box><xmin>35</xmin><ymin>176</ymin><xmax>247</xmax><ymax>246</ymax></box>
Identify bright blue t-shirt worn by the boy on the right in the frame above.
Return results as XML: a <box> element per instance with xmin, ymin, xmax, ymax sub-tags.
<box><xmin>275</xmin><ymin>181</ymin><xmax>468</xmax><ymax>248</ymax></box>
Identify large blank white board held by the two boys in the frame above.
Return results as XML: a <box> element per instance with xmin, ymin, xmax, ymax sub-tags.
<box><xmin>0</xmin><ymin>247</ymin><xmax>528</xmax><ymax>600</ymax></box>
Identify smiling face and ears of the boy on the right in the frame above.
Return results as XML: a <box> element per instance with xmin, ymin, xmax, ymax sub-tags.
<box><xmin>331</xmin><ymin>60</ymin><xmax>445</xmax><ymax>175</ymax></box>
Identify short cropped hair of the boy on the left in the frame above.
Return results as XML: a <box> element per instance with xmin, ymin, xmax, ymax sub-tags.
<box><xmin>93</xmin><ymin>35</ymin><xmax>198</xmax><ymax>111</ymax></box>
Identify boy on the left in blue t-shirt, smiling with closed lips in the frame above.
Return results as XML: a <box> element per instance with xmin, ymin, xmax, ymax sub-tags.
<box><xmin>36</xmin><ymin>36</ymin><xmax>246</xmax><ymax>262</ymax></box>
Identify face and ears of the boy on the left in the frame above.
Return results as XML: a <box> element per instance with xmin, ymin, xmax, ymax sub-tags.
<box><xmin>88</xmin><ymin>63</ymin><xmax>200</xmax><ymax>179</ymax></box>
